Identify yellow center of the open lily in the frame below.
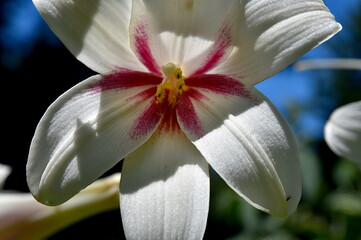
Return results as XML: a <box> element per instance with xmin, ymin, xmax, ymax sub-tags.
<box><xmin>155</xmin><ymin>63</ymin><xmax>188</xmax><ymax>107</ymax></box>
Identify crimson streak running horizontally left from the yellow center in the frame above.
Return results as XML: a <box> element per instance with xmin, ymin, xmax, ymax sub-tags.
<box><xmin>90</xmin><ymin>69</ymin><xmax>162</xmax><ymax>93</ymax></box>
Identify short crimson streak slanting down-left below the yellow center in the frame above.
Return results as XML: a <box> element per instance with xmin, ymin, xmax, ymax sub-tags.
<box><xmin>130</xmin><ymin>99</ymin><xmax>162</xmax><ymax>139</ymax></box>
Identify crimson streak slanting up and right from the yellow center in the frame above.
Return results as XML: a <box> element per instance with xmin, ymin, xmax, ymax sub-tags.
<box><xmin>191</xmin><ymin>24</ymin><xmax>233</xmax><ymax>76</ymax></box>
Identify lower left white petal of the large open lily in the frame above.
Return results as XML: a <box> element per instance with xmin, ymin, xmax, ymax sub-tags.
<box><xmin>27</xmin><ymin>73</ymin><xmax>160</xmax><ymax>205</ymax></box>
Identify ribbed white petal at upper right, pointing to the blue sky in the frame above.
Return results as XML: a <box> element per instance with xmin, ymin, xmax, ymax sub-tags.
<box><xmin>213</xmin><ymin>0</ymin><xmax>341</xmax><ymax>85</ymax></box>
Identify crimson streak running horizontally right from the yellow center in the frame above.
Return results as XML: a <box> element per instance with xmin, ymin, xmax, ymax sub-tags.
<box><xmin>186</xmin><ymin>74</ymin><xmax>251</xmax><ymax>98</ymax></box>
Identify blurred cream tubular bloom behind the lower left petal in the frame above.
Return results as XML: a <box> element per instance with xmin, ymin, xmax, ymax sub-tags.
<box><xmin>0</xmin><ymin>171</ymin><xmax>120</xmax><ymax>240</ymax></box>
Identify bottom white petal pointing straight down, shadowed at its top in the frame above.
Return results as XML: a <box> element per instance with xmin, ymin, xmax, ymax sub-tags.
<box><xmin>120</xmin><ymin>134</ymin><xmax>209</xmax><ymax>239</ymax></box>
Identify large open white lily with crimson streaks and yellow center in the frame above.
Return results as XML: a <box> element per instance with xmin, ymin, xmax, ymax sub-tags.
<box><xmin>27</xmin><ymin>0</ymin><xmax>341</xmax><ymax>239</ymax></box>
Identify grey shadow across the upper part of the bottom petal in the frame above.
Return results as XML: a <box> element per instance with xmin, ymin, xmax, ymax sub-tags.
<box><xmin>121</xmin><ymin>133</ymin><xmax>208</xmax><ymax>194</ymax></box>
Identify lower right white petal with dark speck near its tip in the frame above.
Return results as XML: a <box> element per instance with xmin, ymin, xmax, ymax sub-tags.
<box><xmin>179</xmin><ymin>87</ymin><xmax>301</xmax><ymax>217</ymax></box>
